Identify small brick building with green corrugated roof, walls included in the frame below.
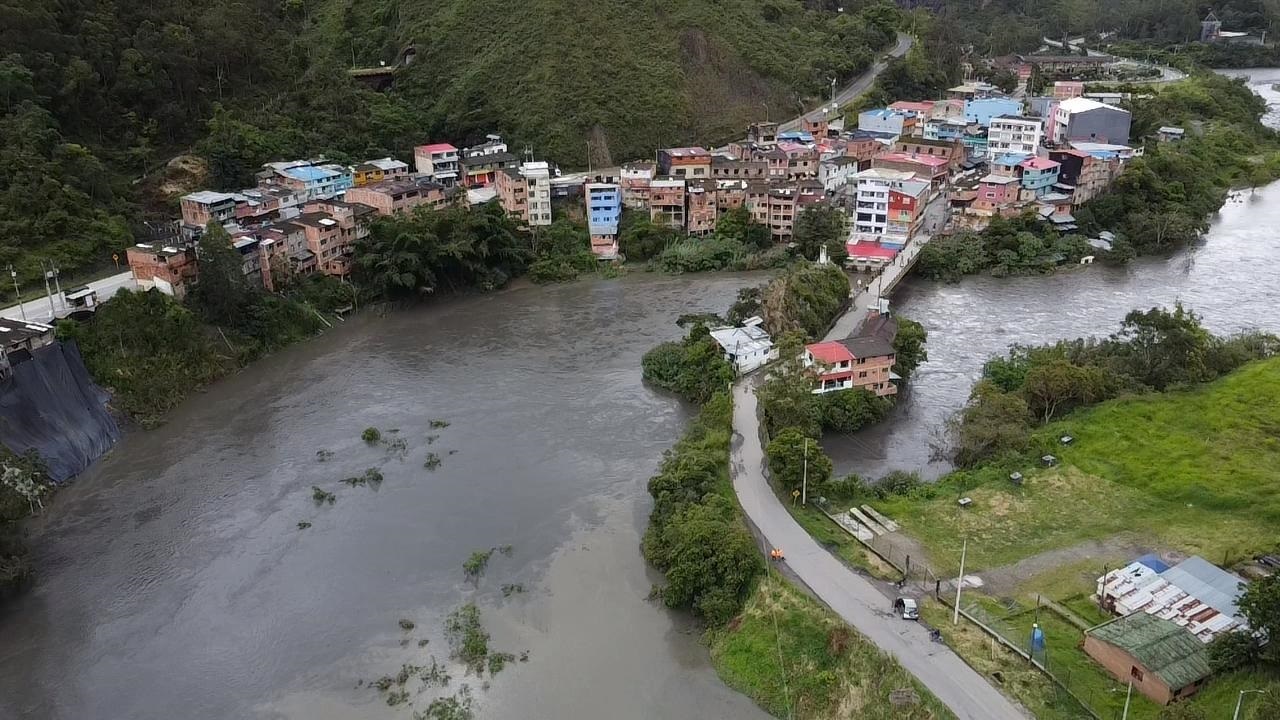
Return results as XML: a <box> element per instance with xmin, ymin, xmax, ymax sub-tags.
<box><xmin>1084</xmin><ymin>612</ymin><xmax>1212</xmax><ymax>705</ymax></box>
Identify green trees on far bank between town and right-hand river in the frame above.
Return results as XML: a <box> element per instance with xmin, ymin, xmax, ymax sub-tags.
<box><xmin>916</xmin><ymin>73</ymin><xmax>1280</xmax><ymax>281</ymax></box>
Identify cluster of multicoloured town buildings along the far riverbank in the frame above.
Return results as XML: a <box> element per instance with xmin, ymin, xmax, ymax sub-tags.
<box><xmin>127</xmin><ymin>65</ymin><xmax>1152</xmax><ymax>297</ymax></box>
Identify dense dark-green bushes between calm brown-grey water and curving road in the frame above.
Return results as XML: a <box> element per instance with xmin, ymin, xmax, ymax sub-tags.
<box><xmin>644</xmin><ymin>392</ymin><xmax>763</xmax><ymax>625</ymax></box>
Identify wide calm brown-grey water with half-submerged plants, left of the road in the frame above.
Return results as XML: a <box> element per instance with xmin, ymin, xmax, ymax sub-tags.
<box><xmin>0</xmin><ymin>275</ymin><xmax>767</xmax><ymax>720</ymax></box>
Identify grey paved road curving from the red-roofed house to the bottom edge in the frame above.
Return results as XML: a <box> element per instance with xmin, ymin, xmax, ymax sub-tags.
<box><xmin>731</xmin><ymin>379</ymin><xmax>1028</xmax><ymax>720</ymax></box>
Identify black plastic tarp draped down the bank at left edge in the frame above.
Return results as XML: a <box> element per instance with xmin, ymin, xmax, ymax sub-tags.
<box><xmin>0</xmin><ymin>342</ymin><xmax>120</xmax><ymax>483</ymax></box>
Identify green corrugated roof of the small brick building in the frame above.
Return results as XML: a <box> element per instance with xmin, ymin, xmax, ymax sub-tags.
<box><xmin>1088</xmin><ymin>610</ymin><xmax>1212</xmax><ymax>691</ymax></box>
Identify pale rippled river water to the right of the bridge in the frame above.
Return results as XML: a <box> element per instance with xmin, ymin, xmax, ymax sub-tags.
<box><xmin>823</xmin><ymin>69</ymin><xmax>1280</xmax><ymax>478</ymax></box>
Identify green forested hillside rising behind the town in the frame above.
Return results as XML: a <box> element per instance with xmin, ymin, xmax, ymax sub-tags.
<box><xmin>0</xmin><ymin>0</ymin><xmax>897</xmax><ymax>281</ymax></box>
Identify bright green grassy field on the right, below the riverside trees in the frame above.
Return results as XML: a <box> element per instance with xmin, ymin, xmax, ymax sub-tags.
<box><xmin>877</xmin><ymin>359</ymin><xmax>1280</xmax><ymax>571</ymax></box>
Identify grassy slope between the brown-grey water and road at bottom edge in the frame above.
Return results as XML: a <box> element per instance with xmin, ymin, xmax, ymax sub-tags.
<box><xmin>709</xmin><ymin>573</ymin><xmax>955</xmax><ymax>720</ymax></box>
